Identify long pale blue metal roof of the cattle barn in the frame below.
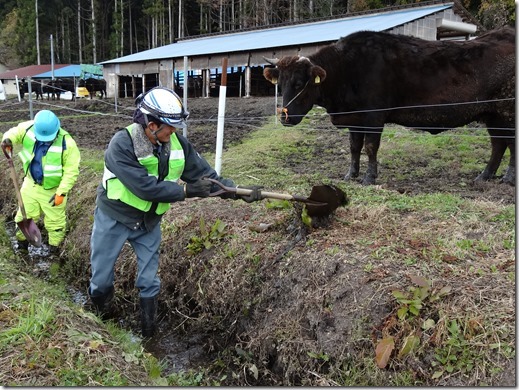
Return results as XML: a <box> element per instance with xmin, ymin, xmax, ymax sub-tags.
<box><xmin>101</xmin><ymin>3</ymin><xmax>453</xmax><ymax>64</ymax></box>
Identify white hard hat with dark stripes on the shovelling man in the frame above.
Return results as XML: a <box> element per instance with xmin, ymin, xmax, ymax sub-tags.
<box><xmin>135</xmin><ymin>87</ymin><xmax>189</xmax><ymax>128</ymax></box>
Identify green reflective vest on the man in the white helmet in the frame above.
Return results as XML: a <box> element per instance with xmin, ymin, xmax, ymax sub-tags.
<box><xmin>103</xmin><ymin>125</ymin><xmax>186</xmax><ymax>215</ymax></box>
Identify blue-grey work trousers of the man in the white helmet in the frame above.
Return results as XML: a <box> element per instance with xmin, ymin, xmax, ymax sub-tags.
<box><xmin>88</xmin><ymin>207</ymin><xmax>161</xmax><ymax>298</ymax></box>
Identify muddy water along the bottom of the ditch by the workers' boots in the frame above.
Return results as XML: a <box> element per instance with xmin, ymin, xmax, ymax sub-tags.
<box><xmin>5</xmin><ymin>221</ymin><xmax>207</xmax><ymax>375</ymax></box>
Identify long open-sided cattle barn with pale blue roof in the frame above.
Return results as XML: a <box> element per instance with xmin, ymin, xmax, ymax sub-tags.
<box><xmin>101</xmin><ymin>0</ymin><xmax>481</xmax><ymax>97</ymax></box>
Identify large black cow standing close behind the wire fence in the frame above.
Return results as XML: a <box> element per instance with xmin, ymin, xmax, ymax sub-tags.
<box><xmin>264</xmin><ymin>27</ymin><xmax>515</xmax><ymax>185</ymax></box>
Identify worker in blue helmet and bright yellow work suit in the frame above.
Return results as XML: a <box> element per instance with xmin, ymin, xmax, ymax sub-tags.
<box><xmin>1</xmin><ymin>110</ymin><xmax>80</xmax><ymax>255</ymax></box>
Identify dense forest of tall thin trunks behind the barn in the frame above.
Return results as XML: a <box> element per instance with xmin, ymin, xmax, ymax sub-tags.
<box><xmin>0</xmin><ymin>0</ymin><xmax>515</xmax><ymax>69</ymax></box>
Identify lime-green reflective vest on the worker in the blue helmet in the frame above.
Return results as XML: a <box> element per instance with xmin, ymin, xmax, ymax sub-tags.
<box><xmin>18</xmin><ymin>126</ymin><xmax>68</xmax><ymax>190</ymax></box>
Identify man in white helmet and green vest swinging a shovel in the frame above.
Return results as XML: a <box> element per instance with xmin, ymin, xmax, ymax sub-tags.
<box><xmin>88</xmin><ymin>87</ymin><xmax>260</xmax><ymax>337</ymax></box>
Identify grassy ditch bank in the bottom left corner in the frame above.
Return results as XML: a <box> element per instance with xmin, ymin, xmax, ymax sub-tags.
<box><xmin>0</xmin><ymin>216</ymin><xmax>169</xmax><ymax>386</ymax></box>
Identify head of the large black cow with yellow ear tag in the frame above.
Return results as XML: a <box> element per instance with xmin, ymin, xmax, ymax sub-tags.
<box><xmin>263</xmin><ymin>56</ymin><xmax>326</xmax><ymax>125</ymax></box>
